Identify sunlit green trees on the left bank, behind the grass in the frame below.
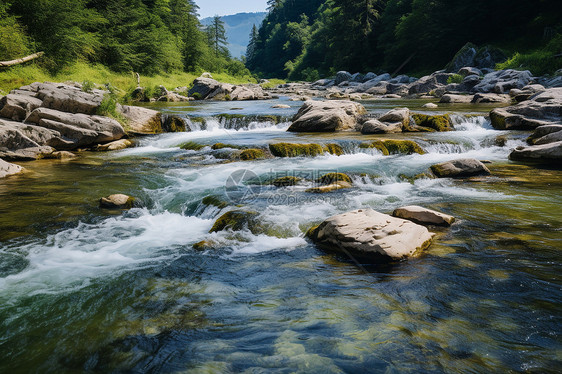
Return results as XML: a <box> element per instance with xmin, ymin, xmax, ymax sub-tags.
<box><xmin>0</xmin><ymin>0</ymin><xmax>249</xmax><ymax>75</ymax></box>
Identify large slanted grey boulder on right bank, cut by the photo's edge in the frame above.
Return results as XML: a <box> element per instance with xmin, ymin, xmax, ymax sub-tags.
<box><xmin>490</xmin><ymin>88</ymin><xmax>562</xmax><ymax>130</ymax></box>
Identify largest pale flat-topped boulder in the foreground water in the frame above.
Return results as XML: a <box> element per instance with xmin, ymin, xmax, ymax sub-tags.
<box><xmin>310</xmin><ymin>209</ymin><xmax>434</xmax><ymax>261</ymax></box>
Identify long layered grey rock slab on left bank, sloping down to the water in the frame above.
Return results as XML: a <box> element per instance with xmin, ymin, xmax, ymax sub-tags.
<box><xmin>26</xmin><ymin>108</ymin><xmax>125</xmax><ymax>149</ymax></box>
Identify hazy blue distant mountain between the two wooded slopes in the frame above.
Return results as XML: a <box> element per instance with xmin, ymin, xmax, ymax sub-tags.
<box><xmin>201</xmin><ymin>12</ymin><xmax>267</xmax><ymax>57</ymax></box>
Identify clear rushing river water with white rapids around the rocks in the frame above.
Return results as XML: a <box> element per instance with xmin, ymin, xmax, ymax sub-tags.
<box><xmin>0</xmin><ymin>98</ymin><xmax>562</xmax><ymax>373</ymax></box>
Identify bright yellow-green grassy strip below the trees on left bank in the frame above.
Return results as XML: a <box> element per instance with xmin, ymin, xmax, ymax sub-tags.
<box><xmin>0</xmin><ymin>63</ymin><xmax>256</xmax><ymax>94</ymax></box>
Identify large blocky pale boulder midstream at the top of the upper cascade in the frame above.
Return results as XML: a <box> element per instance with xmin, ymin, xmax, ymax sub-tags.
<box><xmin>288</xmin><ymin>100</ymin><xmax>367</xmax><ymax>132</ymax></box>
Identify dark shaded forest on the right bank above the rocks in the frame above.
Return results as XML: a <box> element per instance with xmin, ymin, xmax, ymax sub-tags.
<box><xmin>247</xmin><ymin>0</ymin><xmax>562</xmax><ymax>80</ymax></box>
